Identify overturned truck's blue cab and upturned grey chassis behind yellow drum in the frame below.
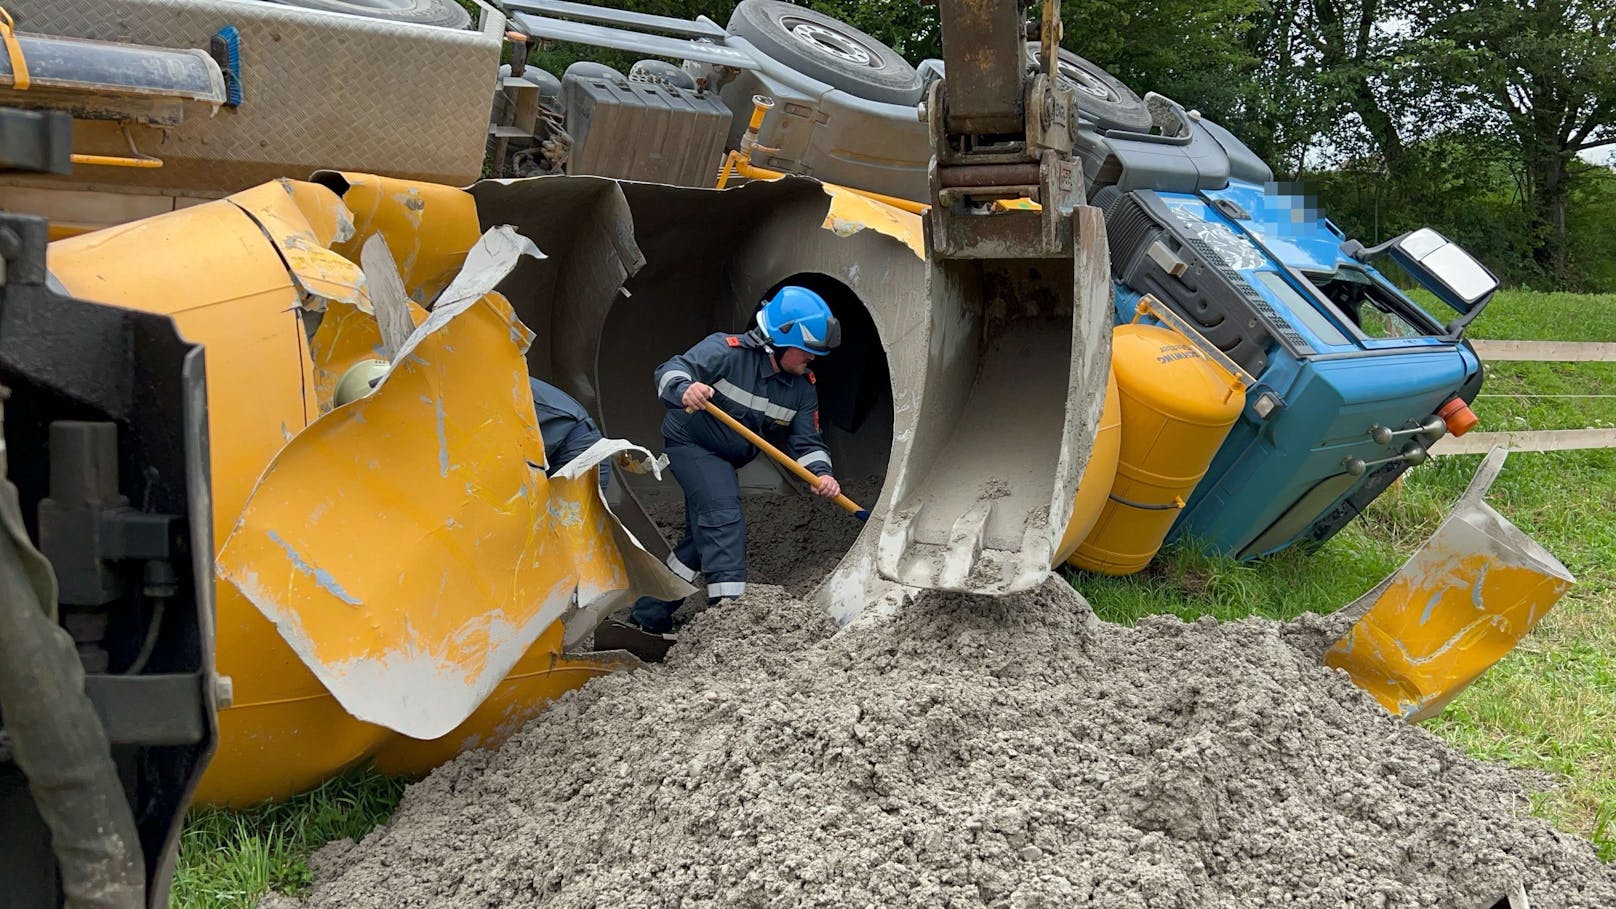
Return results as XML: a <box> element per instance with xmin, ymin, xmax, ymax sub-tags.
<box><xmin>0</xmin><ymin>0</ymin><xmax>1496</xmax><ymax>573</ymax></box>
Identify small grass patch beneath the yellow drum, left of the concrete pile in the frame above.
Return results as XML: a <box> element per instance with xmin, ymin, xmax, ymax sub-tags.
<box><xmin>168</xmin><ymin>770</ymin><xmax>404</xmax><ymax>909</ymax></box>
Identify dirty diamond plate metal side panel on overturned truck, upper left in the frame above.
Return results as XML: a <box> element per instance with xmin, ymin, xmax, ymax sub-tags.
<box><xmin>5</xmin><ymin>0</ymin><xmax>499</xmax><ymax>196</ymax></box>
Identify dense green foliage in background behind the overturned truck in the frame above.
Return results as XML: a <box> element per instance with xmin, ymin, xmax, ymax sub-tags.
<box><xmin>497</xmin><ymin>0</ymin><xmax>1616</xmax><ymax>293</ymax></box>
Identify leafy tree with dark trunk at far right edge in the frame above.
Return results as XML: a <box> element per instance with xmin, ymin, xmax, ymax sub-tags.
<box><xmin>1416</xmin><ymin>0</ymin><xmax>1616</xmax><ymax>283</ymax></box>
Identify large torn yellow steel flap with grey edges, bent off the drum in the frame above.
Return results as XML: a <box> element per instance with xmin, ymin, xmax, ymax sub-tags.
<box><xmin>218</xmin><ymin>283</ymin><xmax>627</xmax><ymax>739</ymax></box>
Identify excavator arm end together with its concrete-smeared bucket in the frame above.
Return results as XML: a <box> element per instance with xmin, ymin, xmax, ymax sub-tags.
<box><xmin>876</xmin><ymin>0</ymin><xmax>1110</xmax><ymax>595</ymax></box>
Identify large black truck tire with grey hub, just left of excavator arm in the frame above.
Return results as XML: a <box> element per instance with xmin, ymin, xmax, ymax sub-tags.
<box><xmin>729</xmin><ymin>0</ymin><xmax>923</xmax><ymax>105</ymax></box>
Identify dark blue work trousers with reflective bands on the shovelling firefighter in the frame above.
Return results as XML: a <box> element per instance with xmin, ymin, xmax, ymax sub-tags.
<box><xmin>629</xmin><ymin>445</ymin><xmax>747</xmax><ymax>632</ymax></box>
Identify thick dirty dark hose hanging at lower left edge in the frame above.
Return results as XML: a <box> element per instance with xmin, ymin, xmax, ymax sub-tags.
<box><xmin>0</xmin><ymin>420</ymin><xmax>145</xmax><ymax>909</ymax></box>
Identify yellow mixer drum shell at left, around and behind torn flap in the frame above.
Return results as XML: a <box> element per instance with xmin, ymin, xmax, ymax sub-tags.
<box><xmin>48</xmin><ymin>181</ymin><xmax>646</xmax><ymax>805</ymax></box>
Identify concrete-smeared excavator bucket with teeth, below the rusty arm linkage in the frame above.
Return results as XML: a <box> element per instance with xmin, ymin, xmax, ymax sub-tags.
<box><xmin>877</xmin><ymin>205</ymin><xmax>1110</xmax><ymax>595</ymax></box>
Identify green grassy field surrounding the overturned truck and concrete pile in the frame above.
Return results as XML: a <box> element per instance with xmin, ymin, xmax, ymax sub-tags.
<box><xmin>173</xmin><ymin>293</ymin><xmax>1616</xmax><ymax>909</ymax></box>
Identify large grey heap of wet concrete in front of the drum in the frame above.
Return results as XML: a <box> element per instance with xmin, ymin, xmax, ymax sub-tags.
<box><xmin>271</xmin><ymin>559</ymin><xmax>1616</xmax><ymax>909</ymax></box>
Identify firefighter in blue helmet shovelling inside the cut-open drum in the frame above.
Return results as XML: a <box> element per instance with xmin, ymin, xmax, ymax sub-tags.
<box><xmin>629</xmin><ymin>285</ymin><xmax>842</xmax><ymax>634</ymax></box>
